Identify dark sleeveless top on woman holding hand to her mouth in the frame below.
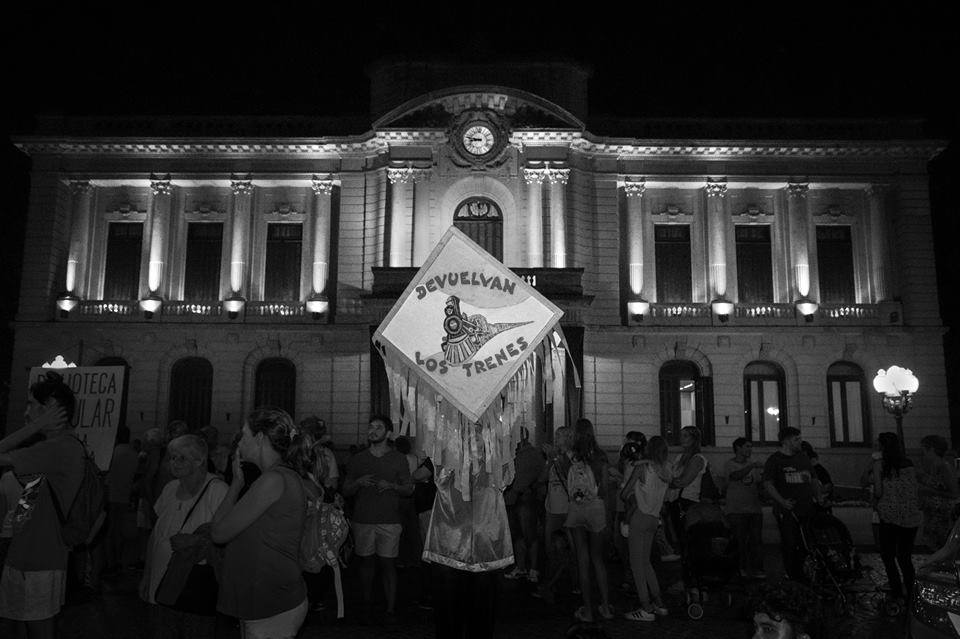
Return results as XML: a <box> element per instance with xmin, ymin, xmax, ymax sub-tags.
<box><xmin>217</xmin><ymin>466</ymin><xmax>307</xmax><ymax>620</ymax></box>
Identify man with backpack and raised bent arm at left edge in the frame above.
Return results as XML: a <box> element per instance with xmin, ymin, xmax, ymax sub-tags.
<box><xmin>0</xmin><ymin>371</ymin><xmax>85</xmax><ymax>639</ymax></box>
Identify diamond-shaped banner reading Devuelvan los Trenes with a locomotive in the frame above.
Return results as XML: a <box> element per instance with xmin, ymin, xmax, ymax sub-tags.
<box><xmin>373</xmin><ymin>227</ymin><xmax>563</xmax><ymax>421</ymax></box>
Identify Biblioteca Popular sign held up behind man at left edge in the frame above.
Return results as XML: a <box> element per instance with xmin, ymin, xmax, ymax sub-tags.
<box><xmin>28</xmin><ymin>366</ymin><xmax>124</xmax><ymax>470</ymax></box>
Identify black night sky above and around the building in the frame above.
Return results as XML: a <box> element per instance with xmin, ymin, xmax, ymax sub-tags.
<box><xmin>0</xmin><ymin>2</ymin><xmax>960</xmax><ymax>436</ymax></box>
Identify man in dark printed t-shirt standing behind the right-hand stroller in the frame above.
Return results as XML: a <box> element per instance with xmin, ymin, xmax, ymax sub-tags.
<box><xmin>763</xmin><ymin>426</ymin><xmax>819</xmax><ymax>580</ymax></box>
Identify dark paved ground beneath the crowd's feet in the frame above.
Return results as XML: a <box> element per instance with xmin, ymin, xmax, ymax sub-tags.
<box><xmin>0</xmin><ymin>547</ymin><xmax>916</xmax><ymax>639</ymax></box>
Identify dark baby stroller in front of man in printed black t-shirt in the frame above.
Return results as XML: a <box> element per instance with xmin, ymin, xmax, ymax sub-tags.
<box><xmin>800</xmin><ymin>511</ymin><xmax>902</xmax><ymax>617</ymax></box>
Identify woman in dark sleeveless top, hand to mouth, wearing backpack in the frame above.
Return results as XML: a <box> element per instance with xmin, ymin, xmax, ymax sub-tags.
<box><xmin>210</xmin><ymin>407</ymin><xmax>315</xmax><ymax>639</ymax></box>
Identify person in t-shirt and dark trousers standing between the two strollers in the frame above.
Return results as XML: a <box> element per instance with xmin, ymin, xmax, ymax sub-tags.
<box><xmin>723</xmin><ymin>437</ymin><xmax>766</xmax><ymax>579</ymax></box>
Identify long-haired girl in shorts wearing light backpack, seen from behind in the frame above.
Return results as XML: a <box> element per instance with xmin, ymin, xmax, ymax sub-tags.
<box><xmin>564</xmin><ymin>418</ymin><xmax>613</xmax><ymax>622</ymax></box>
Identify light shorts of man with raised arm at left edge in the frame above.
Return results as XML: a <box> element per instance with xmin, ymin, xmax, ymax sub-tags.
<box><xmin>0</xmin><ymin>566</ymin><xmax>67</xmax><ymax>621</ymax></box>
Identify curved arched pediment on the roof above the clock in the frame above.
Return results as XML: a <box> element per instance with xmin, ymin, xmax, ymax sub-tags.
<box><xmin>373</xmin><ymin>85</ymin><xmax>585</xmax><ymax>131</ymax></box>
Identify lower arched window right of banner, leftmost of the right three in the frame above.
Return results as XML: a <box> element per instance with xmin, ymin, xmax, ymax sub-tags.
<box><xmin>660</xmin><ymin>360</ymin><xmax>714</xmax><ymax>445</ymax></box>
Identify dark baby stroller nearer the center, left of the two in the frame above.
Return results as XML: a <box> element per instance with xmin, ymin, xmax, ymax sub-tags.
<box><xmin>683</xmin><ymin>503</ymin><xmax>739</xmax><ymax>619</ymax></box>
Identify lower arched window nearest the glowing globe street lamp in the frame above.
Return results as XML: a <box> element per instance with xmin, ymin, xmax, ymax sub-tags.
<box><xmin>827</xmin><ymin>362</ymin><xmax>870</xmax><ymax>446</ymax></box>
